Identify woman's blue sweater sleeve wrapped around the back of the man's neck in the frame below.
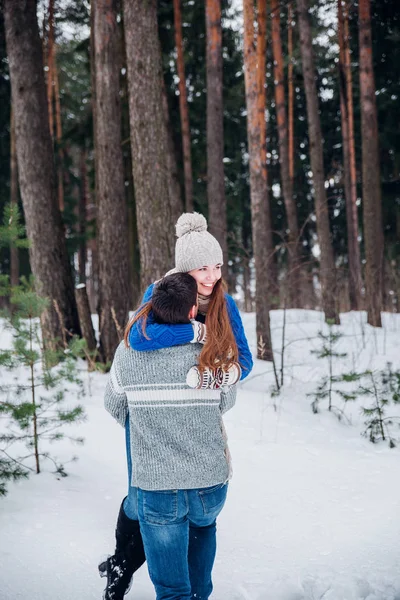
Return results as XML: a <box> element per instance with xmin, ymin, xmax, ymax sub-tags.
<box><xmin>129</xmin><ymin>283</ymin><xmax>194</xmax><ymax>351</ymax></box>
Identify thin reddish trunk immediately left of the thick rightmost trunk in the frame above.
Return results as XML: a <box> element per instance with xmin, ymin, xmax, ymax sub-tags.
<box><xmin>338</xmin><ymin>0</ymin><xmax>362</xmax><ymax>310</ymax></box>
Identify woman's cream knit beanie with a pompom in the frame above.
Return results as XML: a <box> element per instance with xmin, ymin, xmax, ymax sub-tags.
<box><xmin>175</xmin><ymin>213</ymin><xmax>224</xmax><ymax>273</ymax></box>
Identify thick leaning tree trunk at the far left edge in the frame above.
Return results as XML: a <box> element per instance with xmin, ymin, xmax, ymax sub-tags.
<box><xmin>4</xmin><ymin>0</ymin><xmax>80</xmax><ymax>346</ymax></box>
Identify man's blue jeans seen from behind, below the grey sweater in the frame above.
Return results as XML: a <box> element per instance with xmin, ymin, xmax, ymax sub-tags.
<box><xmin>137</xmin><ymin>484</ymin><xmax>228</xmax><ymax>600</ymax></box>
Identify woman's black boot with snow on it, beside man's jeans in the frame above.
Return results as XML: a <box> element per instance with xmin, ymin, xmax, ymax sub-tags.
<box><xmin>99</xmin><ymin>502</ymin><xmax>146</xmax><ymax>600</ymax></box>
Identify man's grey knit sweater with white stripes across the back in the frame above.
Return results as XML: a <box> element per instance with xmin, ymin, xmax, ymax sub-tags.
<box><xmin>104</xmin><ymin>343</ymin><xmax>236</xmax><ymax>490</ymax></box>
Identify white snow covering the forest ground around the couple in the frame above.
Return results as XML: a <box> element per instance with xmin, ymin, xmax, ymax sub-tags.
<box><xmin>0</xmin><ymin>310</ymin><xmax>400</xmax><ymax>600</ymax></box>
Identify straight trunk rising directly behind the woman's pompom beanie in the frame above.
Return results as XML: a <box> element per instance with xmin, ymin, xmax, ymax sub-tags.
<box><xmin>206</xmin><ymin>0</ymin><xmax>228</xmax><ymax>279</ymax></box>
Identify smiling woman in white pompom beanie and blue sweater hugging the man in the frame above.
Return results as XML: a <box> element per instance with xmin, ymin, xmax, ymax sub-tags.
<box><xmin>99</xmin><ymin>213</ymin><xmax>253</xmax><ymax>600</ymax></box>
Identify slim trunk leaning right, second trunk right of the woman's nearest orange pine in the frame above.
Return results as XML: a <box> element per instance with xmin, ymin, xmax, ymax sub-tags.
<box><xmin>296</xmin><ymin>0</ymin><xmax>340</xmax><ymax>323</ymax></box>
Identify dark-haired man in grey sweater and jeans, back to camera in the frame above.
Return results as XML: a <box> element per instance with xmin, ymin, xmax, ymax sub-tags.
<box><xmin>105</xmin><ymin>273</ymin><xmax>236</xmax><ymax>600</ymax></box>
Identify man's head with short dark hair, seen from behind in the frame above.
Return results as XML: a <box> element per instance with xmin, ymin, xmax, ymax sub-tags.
<box><xmin>151</xmin><ymin>273</ymin><xmax>197</xmax><ymax>323</ymax></box>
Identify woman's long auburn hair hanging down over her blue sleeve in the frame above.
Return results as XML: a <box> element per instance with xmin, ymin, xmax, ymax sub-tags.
<box><xmin>198</xmin><ymin>279</ymin><xmax>239</xmax><ymax>371</ymax></box>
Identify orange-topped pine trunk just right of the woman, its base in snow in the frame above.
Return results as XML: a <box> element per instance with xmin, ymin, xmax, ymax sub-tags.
<box><xmin>243</xmin><ymin>0</ymin><xmax>274</xmax><ymax>360</ymax></box>
